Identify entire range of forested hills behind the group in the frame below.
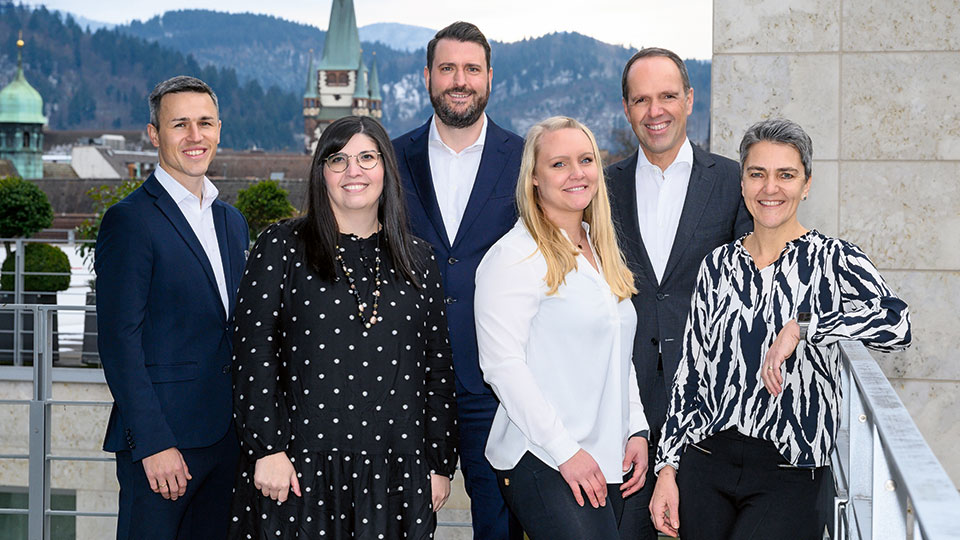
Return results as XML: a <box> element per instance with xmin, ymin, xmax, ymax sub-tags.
<box><xmin>0</xmin><ymin>5</ymin><xmax>710</xmax><ymax>155</ymax></box>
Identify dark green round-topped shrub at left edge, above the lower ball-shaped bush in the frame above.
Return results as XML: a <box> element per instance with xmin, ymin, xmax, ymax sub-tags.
<box><xmin>0</xmin><ymin>176</ymin><xmax>53</xmax><ymax>251</ymax></box>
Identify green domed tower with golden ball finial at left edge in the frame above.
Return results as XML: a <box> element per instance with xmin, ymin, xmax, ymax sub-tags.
<box><xmin>0</xmin><ymin>32</ymin><xmax>47</xmax><ymax>178</ymax></box>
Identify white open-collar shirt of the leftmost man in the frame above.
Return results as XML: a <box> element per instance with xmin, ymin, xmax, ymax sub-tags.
<box><xmin>153</xmin><ymin>165</ymin><xmax>230</xmax><ymax>316</ymax></box>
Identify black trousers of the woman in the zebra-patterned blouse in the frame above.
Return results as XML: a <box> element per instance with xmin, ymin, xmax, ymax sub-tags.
<box><xmin>677</xmin><ymin>430</ymin><xmax>830</xmax><ymax>540</ymax></box>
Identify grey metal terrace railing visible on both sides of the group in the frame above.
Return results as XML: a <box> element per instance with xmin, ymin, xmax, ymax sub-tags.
<box><xmin>0</xmin><ymin>304</ymin><xmax>960</xmax><ymax>540</ymax></box>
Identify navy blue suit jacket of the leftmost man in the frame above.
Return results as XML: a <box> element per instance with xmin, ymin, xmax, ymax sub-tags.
<box><xmin>95</xmin><ymin>175</ymin><xmax>249</xmax><ymax>461</ymax></box>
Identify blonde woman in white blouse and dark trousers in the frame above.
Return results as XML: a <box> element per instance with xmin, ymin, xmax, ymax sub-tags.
<box><xmin>475</xmin><ymin>117</ymin><xmax>647</xmax><ymax>540</ymax></box>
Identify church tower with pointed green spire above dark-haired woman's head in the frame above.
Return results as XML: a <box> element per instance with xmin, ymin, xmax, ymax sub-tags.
<box><xmin>303</xmin><ymin>0</ymin><xmax>383</xmax><ymax>153</ymax></box>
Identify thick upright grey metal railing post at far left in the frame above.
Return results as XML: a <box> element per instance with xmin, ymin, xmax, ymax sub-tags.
<box><xmin>27</xmin><ymin>306</ymin><xmax>52</xmax><ymax>540</ymax></box>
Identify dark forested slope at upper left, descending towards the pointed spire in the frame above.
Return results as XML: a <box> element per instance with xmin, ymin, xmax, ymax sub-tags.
<box><xmin>0</xmin><ymin>4</ymin><xmax>302</xmax><ymax>151</ymax></box>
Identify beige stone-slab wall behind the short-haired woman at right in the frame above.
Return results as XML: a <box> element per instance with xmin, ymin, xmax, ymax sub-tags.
<box><xmin>711</xmin><ymin>0</ymin><xmax>960</xmax><ymax>485</ymax></box>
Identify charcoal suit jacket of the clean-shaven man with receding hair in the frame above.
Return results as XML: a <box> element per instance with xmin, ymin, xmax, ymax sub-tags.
<box><xmin>606</xmin><ymin>146</ymin><xmax>753</xmax><ymax>433</ymax></box>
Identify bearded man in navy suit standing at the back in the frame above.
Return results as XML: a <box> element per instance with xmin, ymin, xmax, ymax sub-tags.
<box><xmin>393</xmin><ymin>22</ymin><xmax>523</xmax><ymax>540</ymax></box>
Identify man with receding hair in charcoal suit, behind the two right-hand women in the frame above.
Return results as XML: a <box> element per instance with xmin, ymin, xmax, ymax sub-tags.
<box><xmin>606</xmin><ymin>48</ymin><xmax>753</xmax><ymax>540</ymax></box>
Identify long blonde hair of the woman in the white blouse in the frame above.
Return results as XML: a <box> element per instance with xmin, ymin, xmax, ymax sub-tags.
<box><xmin>517</xmin><ymin>116</ymin><xmax>637</xmax><ymax>300</ymax></box>
